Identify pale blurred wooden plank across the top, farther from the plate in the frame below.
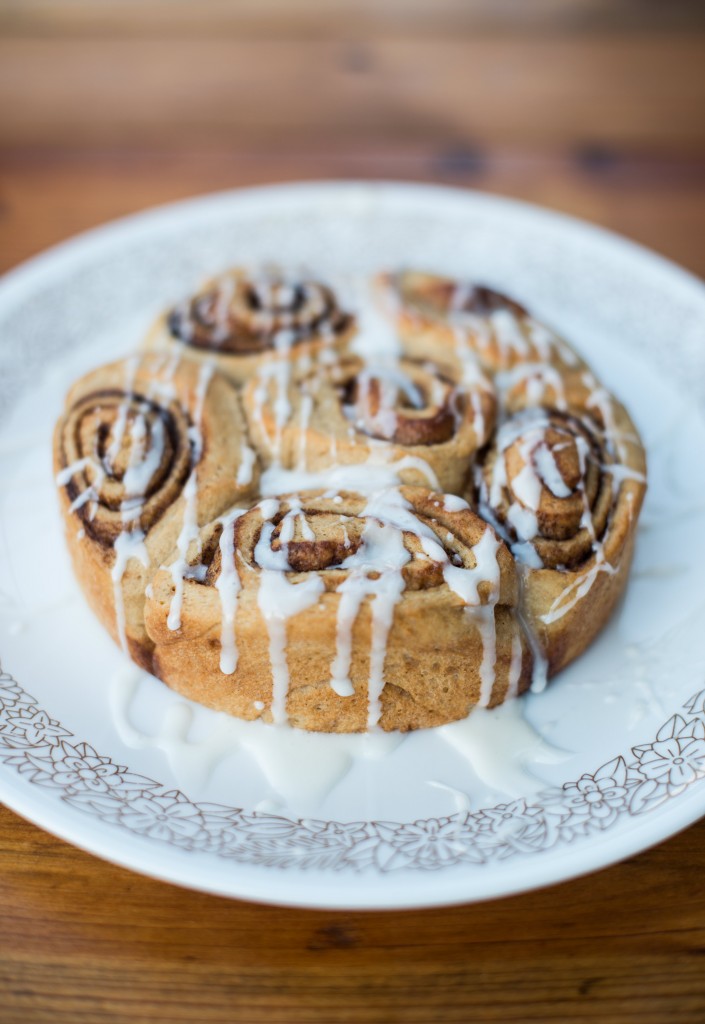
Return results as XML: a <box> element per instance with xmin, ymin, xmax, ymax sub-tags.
<box><xmin>0</xmin><ymin>33</ymin><xmax>705</xmax><ymax>150</ymax></box>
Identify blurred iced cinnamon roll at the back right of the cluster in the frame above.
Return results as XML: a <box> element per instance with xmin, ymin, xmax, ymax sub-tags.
<box><xmin>377</xmin><ymin>271</ymin><xmax>582</xmax><ymax>374</ymax></box>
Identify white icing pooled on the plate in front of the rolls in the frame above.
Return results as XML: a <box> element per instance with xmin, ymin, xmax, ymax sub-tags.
<box><xmin>109</xmin><ymin>666</ymin><xmax>571</xmax><ymax>813</ymax></box>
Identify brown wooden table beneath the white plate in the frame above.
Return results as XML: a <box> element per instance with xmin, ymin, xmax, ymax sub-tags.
<box><xmin>0</xmin><ymin>0</ymin><xmax>705</xmax><ymax>1024</ymax></box>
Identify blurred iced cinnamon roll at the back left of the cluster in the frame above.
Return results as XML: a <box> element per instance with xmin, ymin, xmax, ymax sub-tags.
<box><xmin>146</xmin><ymin>269</ymin><xmax>354</xmax><ymax>384</ymax></box>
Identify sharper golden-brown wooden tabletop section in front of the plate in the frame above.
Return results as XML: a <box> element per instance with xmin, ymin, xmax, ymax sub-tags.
<box><xmin>0</xmin><ymin>811</ymin><xmax>705</xmax><ymax>1024</ymax></box>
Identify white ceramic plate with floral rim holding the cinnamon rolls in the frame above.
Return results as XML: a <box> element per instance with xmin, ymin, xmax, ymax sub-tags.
<box><xmin>0</xmin><ymin>184</ymin><xmax>705</xmax><ymax>908</ymax></box>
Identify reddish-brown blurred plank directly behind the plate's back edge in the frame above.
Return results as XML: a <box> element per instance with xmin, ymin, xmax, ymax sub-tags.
<box><xmin>0</xmin><ymin>140</ymin><xmax>705</xmax><ymax>276</ymax></box>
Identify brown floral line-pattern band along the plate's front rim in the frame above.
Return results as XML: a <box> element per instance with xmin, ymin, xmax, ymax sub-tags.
<box><xmin>0</xmin><ymin>672</ymin><xmax>705</xmax><ymax>871</ymax></box>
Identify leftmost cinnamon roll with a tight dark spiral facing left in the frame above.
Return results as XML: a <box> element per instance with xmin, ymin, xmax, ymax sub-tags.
<box><xmin>54</xmin><ymin>354</ymin><xmax>258</xmax><ymax>669</ymax></box>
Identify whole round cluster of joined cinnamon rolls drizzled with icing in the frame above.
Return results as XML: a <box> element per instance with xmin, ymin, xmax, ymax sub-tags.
<box><xmin>54</xmin><ymin>270</ymin><xmax>646</xmax><ymax>732</ymax></box>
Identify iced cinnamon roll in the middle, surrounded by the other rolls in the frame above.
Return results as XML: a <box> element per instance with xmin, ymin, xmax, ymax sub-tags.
<box><xmin>243</xmin><ymin>357</ymin><xmax>495</xmax><ymax>492</ymax></box>
